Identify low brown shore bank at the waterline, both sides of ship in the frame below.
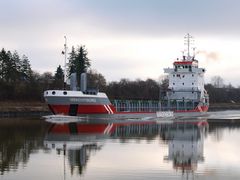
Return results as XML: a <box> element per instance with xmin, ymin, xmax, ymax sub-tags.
<box><xmin>0</xmin><ymin>101</ymin><xmax>240</xmax><ymax>117</ymax></box>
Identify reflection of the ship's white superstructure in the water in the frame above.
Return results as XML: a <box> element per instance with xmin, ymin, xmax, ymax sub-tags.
<box><xmin>164</xmin><ymin>121</ymin><xmax>208</xmax><ymax>179</ymax></box>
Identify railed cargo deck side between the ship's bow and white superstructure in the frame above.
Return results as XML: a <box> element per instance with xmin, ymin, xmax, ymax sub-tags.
<box><xmin>111</xmin><ymin>99</ymin><xmax>160</xmax><ymax>112</ymax></box>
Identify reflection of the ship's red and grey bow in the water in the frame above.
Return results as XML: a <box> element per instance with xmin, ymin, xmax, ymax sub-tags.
<box><xmin>44</xmin><ymin>123</ymin><xmax>109</xmax><ymax>174</ymax></box>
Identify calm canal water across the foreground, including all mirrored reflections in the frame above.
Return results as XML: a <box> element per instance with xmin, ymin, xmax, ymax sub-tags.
<box><xmin>0</xmin><ymin>113</ymin><xmax>240</xmax><ymax>180</ymax></box>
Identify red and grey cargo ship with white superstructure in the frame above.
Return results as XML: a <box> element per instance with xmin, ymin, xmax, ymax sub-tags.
<box><xmin>44</xmin><ymin>34</ymin><xmax>209</xmax><ymax>116</ymax></box>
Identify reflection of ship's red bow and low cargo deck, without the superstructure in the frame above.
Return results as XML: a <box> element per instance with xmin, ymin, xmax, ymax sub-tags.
<box><xmin>44</xmin><ymin>120</ymin><xmax>159</xmax><ymax>175</ymax></box>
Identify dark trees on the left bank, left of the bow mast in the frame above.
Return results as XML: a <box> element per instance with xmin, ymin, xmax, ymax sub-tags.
<box><xmin>0</xmin><ymin>48</ymin><xmax>62</xmax><ymax>101</ymax></box>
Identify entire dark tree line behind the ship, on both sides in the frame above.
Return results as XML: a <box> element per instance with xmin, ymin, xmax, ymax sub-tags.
<box><xmin>0</xmin><ymin>46</ymin><xmax>240</xmax><ymax>103</ymax></box>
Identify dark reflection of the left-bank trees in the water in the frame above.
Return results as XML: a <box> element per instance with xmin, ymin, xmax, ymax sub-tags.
<box><xmin>0</xmin><ymin>119</ymin><xmax>47</xmax><ymax>175</ymax></box>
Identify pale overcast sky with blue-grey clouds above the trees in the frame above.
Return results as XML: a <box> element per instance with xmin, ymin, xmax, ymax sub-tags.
<box><xmin>0</xmin><ymin>0</ymin><xmax>240</xmax><ymax>86</ymax></box>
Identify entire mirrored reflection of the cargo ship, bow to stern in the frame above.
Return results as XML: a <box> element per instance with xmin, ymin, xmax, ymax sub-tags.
<box><xmin>44</xmin><ymin>116</ymin><xmax>208</xmax><ymax>178</ymax></box>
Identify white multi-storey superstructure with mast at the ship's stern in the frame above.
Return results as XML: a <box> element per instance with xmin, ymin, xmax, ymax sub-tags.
<box><xmin>160</xmin><ymin>34</ymin><xmax>208</xmax><ymax>111</ymax></box>
